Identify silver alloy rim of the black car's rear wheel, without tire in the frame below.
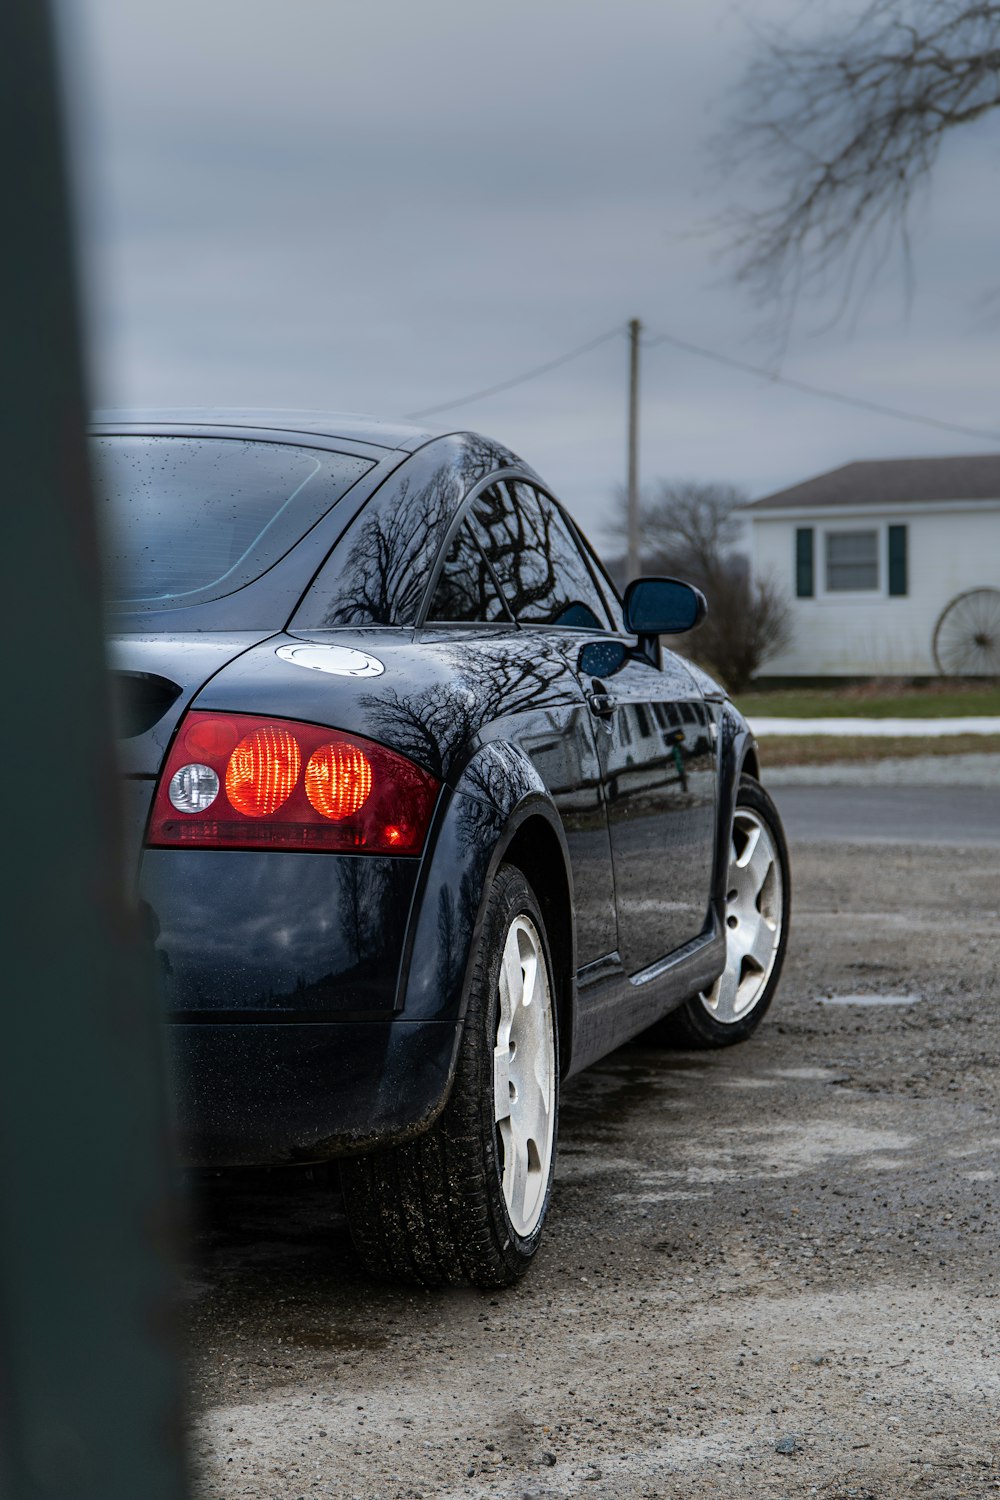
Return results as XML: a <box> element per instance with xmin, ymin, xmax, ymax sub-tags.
<box><xmin>493</xmin><ymin>914</ymin><xmax>556</xmax><ymax>1238</ymax></box>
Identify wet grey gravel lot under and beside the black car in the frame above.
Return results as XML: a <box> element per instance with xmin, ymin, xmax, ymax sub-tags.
<box><xmin>186</xmin><ymin>828</ymin><xmax>1000</xmax><ymax>1500</ymax></box>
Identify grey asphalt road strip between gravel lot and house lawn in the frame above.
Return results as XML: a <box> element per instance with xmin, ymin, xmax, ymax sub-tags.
<box><xmin>771</xmin><ymin>785</ymin><xmax>1000</xmax><ymax>846</ymax></box>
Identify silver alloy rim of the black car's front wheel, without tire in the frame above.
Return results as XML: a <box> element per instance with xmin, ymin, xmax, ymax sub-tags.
<box><xmin>700</xmin><ymin>807</ymin><xmax>783</xmax><ymax>1025</ymax></box>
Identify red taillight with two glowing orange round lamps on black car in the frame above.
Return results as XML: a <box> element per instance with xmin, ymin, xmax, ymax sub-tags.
<box><xmin>145</xmin><ymin>711</ymin><xmax>439</xmax><ymax>855</ymax></box>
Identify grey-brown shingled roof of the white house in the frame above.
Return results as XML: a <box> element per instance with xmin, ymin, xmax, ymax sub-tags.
<box><xmin>744</xmin><ymin>453</ymin><xmax>1000</xmax><ymax>510</ymax></box>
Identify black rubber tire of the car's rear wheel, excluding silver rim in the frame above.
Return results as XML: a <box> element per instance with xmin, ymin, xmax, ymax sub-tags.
<box><xmin>340</xmin><ymin>866</ymin><xmax>559</xmax><ymax>1287</ymax></box>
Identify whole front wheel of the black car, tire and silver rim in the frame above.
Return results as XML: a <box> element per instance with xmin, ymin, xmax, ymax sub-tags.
<box><xmin>663</xmin><ymin>776</ymin><xmax>792</xmax><ymax>1047</ymax></box>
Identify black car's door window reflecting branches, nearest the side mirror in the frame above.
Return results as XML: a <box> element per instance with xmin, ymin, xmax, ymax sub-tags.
<box><xmin>471</xmin><ymin>480</ymin><xmax>607</xmax><ymax>630</ymax></box>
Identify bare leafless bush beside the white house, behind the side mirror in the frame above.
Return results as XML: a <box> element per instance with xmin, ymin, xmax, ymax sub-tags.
<box><xmin>616</xmin><ymin>480</ymin><xmax>790</xmax><ymax>693</ymax></box>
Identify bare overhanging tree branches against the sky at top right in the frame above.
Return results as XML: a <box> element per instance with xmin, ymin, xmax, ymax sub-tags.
<box><xmin>720</xmin><ymin>0</ymin><xmax>1000</xmax><ymax>317</ymax></box>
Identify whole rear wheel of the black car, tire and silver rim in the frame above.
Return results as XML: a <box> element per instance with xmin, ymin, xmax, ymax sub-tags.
<box><xmin>340</xmin><ymin>866</ymin><xmax>559</xmax><ymax>1287</ymax></box>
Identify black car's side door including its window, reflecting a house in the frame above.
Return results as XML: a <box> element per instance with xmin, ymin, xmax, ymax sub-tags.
<box><xmin>472</xmin><ymin>480</ymin><xmax>715</xmax><ymax>975</ymax></box>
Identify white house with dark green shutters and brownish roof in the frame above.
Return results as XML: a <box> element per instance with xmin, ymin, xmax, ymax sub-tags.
<box><xmin>742</xmin><ymin>455</ymin><xmax>1000</xmax><ymax>677</ymax></box>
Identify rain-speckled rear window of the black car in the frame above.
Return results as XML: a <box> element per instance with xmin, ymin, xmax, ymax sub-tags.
<box><xmin>93</xmin><ymin>437</ymin><xmax>372</xmax><ymax>611</ymax></box>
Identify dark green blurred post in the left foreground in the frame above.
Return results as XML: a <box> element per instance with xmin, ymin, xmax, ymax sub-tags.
<box><xmin>0</xmin><ymin>0</ymin><xmax>184</xmax><ymax>1500</ymax></box>
